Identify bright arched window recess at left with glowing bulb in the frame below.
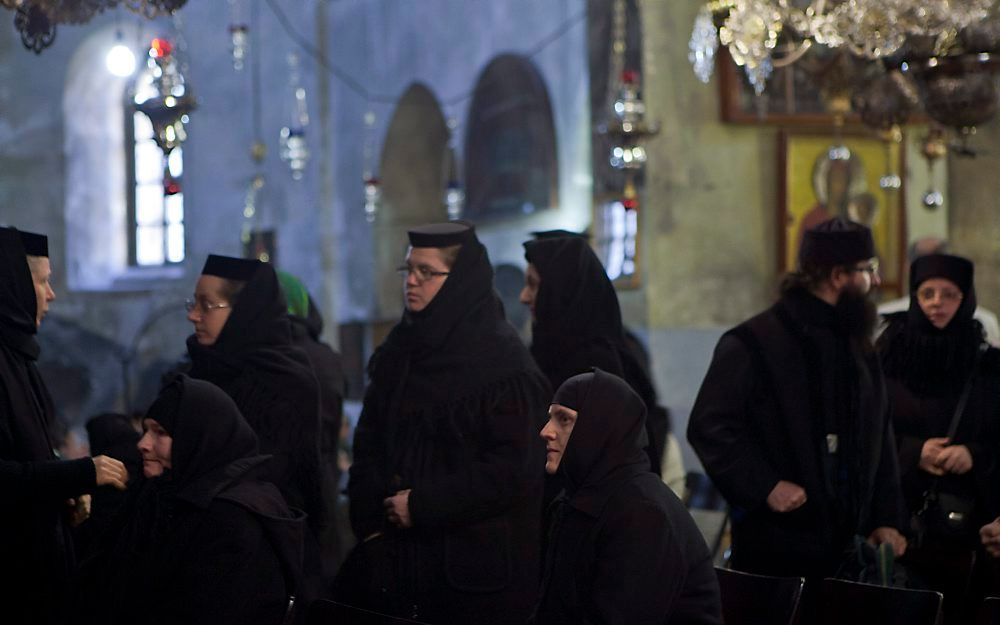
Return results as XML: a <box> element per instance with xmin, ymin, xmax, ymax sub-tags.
<box><xmin>63</xmin><ymin>23</ymin><xmax>184</xmax><ymax>291</ymax></box>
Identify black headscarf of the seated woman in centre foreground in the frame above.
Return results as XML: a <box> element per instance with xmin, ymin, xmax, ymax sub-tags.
<box><xmin>552</xmin><ymin>369</ymin><xmax>649</xmax><ymax>514</ymax></box>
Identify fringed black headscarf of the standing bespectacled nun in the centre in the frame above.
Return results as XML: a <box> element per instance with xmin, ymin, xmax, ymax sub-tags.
<box><xmin>368</xmin><ymin>224</ymin><xmax>534</xmax><ymax>409</ymax></box>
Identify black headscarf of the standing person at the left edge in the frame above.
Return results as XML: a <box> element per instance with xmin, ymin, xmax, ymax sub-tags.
<box><xmin>0</xmin><ymin>228</ymin><xmax>39</xmax><ymax>360</ymax></box>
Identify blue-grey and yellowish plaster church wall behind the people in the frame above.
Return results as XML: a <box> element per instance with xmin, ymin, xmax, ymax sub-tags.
<box><xmin>0</xmin><ymin>0</ymin><xmax>1000</xmax><ymax>462</ymax></box>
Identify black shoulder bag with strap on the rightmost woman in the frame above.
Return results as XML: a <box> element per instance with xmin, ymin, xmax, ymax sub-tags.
<box><xmin>910</xmin><ymin>349</ymin><xmax>983</xmax><ymax>547</ymax></box>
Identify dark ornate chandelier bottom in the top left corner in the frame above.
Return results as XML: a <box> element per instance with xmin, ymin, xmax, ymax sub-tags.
<box><xmin>0</xmin><ymin>0</ymin><xmax>187</xmax><ymax>54</ymax></box>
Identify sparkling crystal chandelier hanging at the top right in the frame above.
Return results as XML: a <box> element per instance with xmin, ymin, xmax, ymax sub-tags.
<box><xmin>688</xmin><ymin>0</ymin><xmax>1000</xmax><ymax>144</ymax></box>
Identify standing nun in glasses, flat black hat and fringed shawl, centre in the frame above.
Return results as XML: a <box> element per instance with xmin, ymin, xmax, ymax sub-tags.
<box><xmin>337</xmin><ymin>222</ymin><xmax>549</xmax><ymax>625</ymax></box>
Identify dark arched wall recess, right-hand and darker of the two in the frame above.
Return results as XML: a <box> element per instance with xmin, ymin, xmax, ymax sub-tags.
<box><xmin>465</xmin><ymin>54</ymin><xmax>559</xmax><ymax>221</ymax></box>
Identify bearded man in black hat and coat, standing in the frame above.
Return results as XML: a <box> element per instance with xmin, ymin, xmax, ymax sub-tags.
<box><xmin>688</xmin><ymin>218</ymin><xmax>906</xmax><ymax>578</ymax></box>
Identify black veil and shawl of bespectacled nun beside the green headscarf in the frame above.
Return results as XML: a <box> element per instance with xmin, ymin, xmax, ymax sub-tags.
<box><xmin>187</xmin><ymin>263</ymin><xmax>326</xmax><ymax>534</ymax></box>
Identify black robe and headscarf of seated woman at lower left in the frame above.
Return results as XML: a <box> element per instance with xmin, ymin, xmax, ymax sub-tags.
<box><xmin>77</xmin><ymin>377</ymin><xmax>305</xmax><ymax>625</ymax></box>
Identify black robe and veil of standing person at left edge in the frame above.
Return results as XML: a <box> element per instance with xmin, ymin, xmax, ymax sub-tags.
<box><xmin>0</xmin><ymin>228</ymin><xmax>96</xmax><ymax>625</ymax></box>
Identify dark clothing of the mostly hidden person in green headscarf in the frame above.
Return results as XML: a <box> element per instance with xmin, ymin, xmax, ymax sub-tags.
<box><xmin>289</xmin><ymin>297</ymin><xmax>347</xmax><ymax>585</ymax></box>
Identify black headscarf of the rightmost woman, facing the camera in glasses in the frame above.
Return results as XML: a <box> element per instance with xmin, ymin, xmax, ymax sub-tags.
<box><xmin>878</xmin><ymin>254</ymin><xmax>985</xmax><ymax>393</ymax></box>
